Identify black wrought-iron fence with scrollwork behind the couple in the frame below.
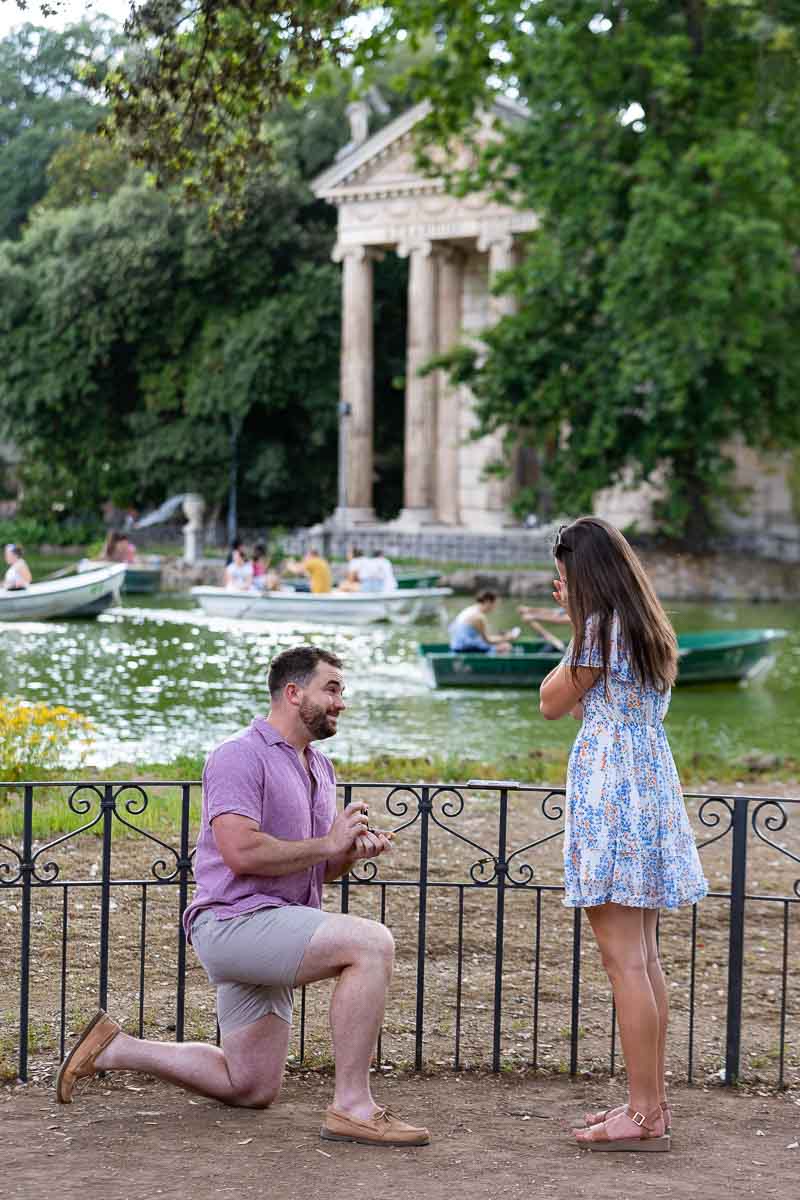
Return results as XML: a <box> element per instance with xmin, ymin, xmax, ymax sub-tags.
<box><xmin>0</xmin><ymin>780</ymin><xmax>800</xmax><ymax>1087</ymax></box>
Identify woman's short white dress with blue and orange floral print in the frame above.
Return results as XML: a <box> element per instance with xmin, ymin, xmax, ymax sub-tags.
<box><xmin>564</xmin><ymin>617</ymin><xmax>708</xmax><ymax>908</ymax></box>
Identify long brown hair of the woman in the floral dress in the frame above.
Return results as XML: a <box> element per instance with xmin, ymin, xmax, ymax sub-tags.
<box><xmin>553</xmin><ymin>517</ymin><xmax>678</xmax><ymax>691</ymax></box>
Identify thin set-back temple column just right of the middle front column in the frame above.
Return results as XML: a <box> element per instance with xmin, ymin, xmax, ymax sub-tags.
<box><xmin>435</xmin><ymin>246</ymin><xmax>464</xmax><ymax>526</ymax></box>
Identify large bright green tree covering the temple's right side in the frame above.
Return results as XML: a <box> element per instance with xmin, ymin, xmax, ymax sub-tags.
<box><xmin>373</xmin><ymin>0</ymin><xmax>800</xmax><ymax>545</ymax></box>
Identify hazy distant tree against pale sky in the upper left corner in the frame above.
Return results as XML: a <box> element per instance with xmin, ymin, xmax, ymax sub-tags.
<box><xmin>0</xmin><ymin>18</ymin><xmax>121</xmax><ymax>240</ymax></box>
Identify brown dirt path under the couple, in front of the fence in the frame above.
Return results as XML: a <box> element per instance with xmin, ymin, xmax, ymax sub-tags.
<box><xmin>0</xmin><ymin>1073</ymin><xmax>800</xmax><ymax>1200</ymax></box>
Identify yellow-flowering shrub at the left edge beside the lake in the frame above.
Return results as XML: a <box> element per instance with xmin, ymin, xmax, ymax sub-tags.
<box><xmin>0</xmin><ymin>696</ymin><xmax>94</xmax><ymax>782</ymax></box>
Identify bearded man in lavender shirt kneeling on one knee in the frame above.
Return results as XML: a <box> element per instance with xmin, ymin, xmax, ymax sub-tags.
<box><xmin>56</xmin><ymin>646</ymin><xmax>431</xmax><ymax>1147</ymax></box>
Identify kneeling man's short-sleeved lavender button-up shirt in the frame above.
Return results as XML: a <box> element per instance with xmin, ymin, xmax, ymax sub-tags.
<box><xmin>184</xmin><ymin>716</ymin><xmax>336</xmax><ymax>940</ymax></box>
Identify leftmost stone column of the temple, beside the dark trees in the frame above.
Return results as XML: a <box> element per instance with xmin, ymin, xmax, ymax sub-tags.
<box><xmin>333</xmin><ymin>246</ymin><xmax>377</xmax><ymax>526</ymax></box>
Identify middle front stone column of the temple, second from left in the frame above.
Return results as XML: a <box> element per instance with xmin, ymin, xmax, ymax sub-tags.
<box><xmin>397</xmin><ymin>241</ymin><xmax>437</xmax><ymax>528</ymax></box>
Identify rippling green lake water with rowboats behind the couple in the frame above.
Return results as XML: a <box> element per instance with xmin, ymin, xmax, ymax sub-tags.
<box><xmin>0</xmin><ymin>595</ymin><xmax>800</xmax><ymax>767</ymax></box>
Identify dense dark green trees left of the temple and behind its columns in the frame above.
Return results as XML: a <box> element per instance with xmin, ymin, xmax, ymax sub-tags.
<box><xmin>0</xmin><ymin>17</ymin><xmax>424</xmax><ymax>525</ymax></box>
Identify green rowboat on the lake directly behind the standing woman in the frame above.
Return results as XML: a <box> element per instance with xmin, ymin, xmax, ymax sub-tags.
<box><xmin>420</xmin><ymin>629</ymin><xmax>788</xmax><ymax>688</ymax></box>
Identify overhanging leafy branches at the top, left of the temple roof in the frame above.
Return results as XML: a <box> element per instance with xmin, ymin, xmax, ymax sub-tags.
<box><xmin>103</xmin><ymin>0</ymin><xmax>362</xmax><ymax>221</ymax></box>
